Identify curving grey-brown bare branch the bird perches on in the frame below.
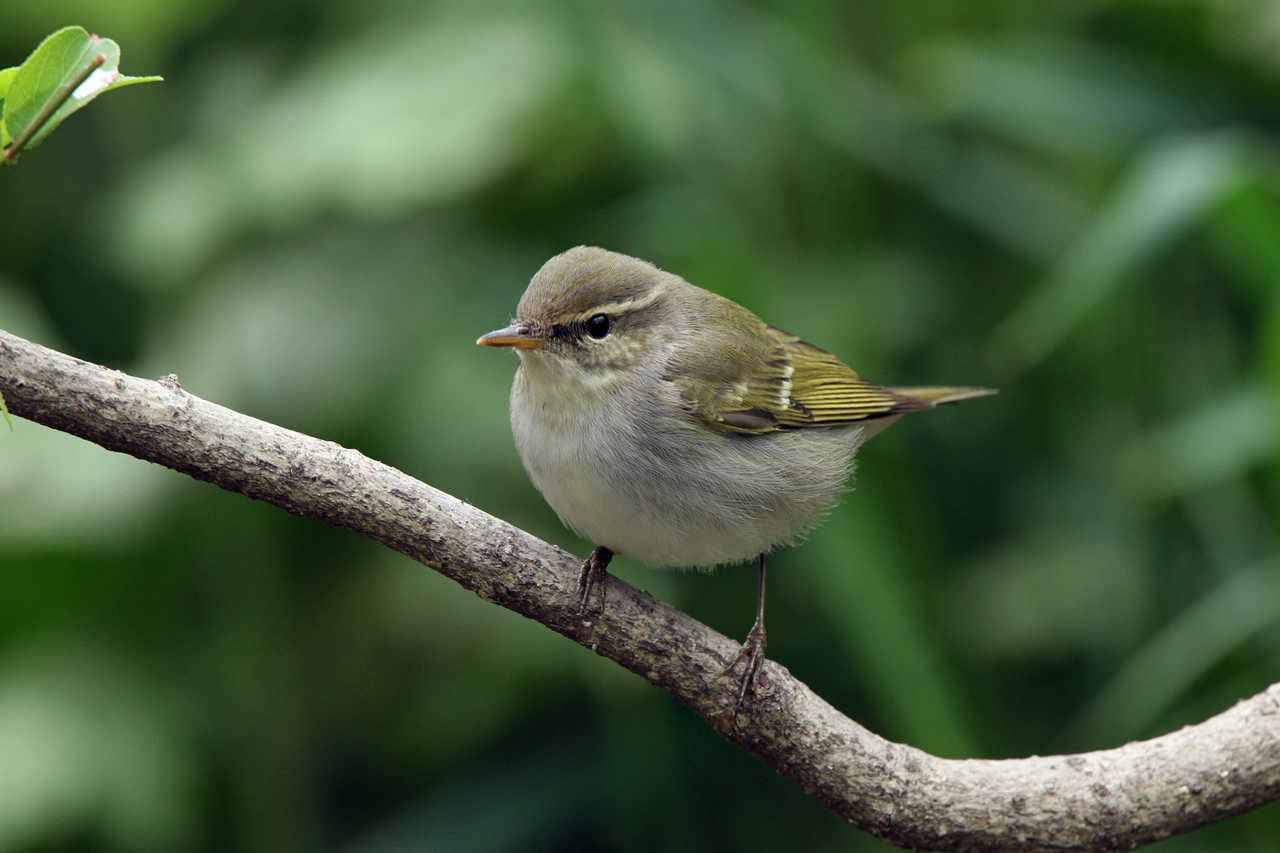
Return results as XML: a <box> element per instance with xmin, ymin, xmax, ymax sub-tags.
<box><xmin>0</xmin><ymin>326</ymin><xmax>1280</xmax><ymax>850</ymax></box>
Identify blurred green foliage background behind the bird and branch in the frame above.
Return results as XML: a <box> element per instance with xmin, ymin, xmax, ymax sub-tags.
<box><xmin>0</xmin><ymin>0</ymin><xmax>1280</xmax><ymax>853</ymax></box>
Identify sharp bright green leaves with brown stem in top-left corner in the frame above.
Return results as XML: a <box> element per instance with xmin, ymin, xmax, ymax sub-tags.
<box><xmin>0</xmin><ymin>27</ymin><xmax>161</xmax><ymax>163</ymax></box>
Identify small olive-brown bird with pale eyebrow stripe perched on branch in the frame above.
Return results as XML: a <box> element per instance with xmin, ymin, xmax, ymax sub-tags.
<box><xmin>476</xmin><ymin>246</ymin><xmax>995</xmax><ymax>701</ymax></box>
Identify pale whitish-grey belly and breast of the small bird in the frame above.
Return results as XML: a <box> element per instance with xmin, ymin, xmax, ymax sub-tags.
<box><xmin>511</xmin><ymin>356</ymin><xmax>863</xmax><ymax>566</ymax></box>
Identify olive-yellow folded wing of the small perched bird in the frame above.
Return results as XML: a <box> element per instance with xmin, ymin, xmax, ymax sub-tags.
<box><xmin>673</xmin><ymin>323</ymin><xmax>921</xmax><ymax>434</ymax></box>
